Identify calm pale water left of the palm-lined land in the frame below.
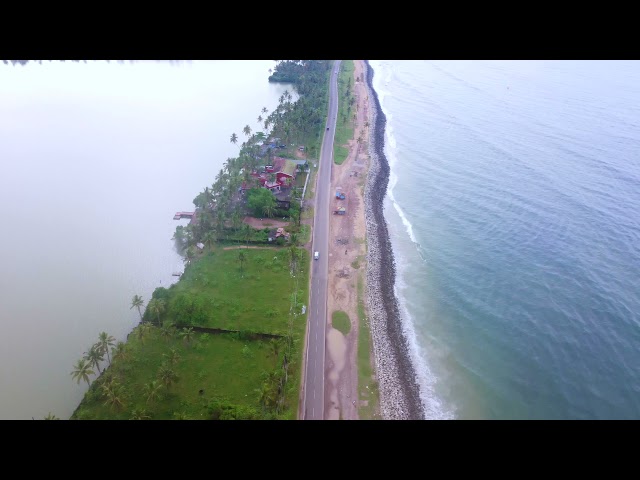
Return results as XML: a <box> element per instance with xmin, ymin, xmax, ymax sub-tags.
<box><xmin>0</xmin><ymin>60</ymin><xmax>295</xmax><ymax>419</ymax></box>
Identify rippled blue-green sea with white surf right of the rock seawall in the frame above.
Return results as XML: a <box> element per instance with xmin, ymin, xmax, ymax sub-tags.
<box><xmin>370</xmin><ymin>60</ymin><xmax>640</xmax><ymax>419</ymax></box>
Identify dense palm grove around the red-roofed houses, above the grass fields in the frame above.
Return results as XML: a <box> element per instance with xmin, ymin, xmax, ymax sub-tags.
<box><xmin>174</xmin><ymin>60</ymin><xmax>331</xmax><ymax>255</ymax></box>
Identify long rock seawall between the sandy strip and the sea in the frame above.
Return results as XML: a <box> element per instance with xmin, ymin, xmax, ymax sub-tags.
<box><xmin>364</xmin><ymin>61</ymin><xmax>425</xmax><ymax>420</ymax></box>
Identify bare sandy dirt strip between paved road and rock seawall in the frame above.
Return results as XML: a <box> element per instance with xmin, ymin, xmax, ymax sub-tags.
<box><xmin>325</xmin><ymin>60</ymin><xmax>369</xmax><ymax>420</ymax></box>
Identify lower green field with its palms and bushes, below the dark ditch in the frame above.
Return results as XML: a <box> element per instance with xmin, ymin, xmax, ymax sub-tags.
<box><xmin>71</xmin><ymin>324</ymin><xmax>298</xmax><ymax>420</ymax></box>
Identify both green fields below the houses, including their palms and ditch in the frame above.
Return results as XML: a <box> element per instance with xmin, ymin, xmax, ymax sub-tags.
<box><xmin>72</xmin><ymin>247</ymin><xmax>309</xmax><ymax>419</ymax></box>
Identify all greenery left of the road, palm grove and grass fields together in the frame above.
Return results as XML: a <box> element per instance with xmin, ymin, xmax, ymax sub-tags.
<box><xmin>72</xmin><ymin>61</ymin><xmax>331</xmax><ymax>420</ymax></box>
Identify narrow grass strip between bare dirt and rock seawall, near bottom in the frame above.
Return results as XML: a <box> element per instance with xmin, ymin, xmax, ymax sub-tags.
<box><xmin>358</xmin><ymin>274</ymin><xmax>378</xmax><ymax>420</ymax></box>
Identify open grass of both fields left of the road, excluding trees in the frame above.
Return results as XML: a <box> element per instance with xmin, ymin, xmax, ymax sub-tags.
<box><xmin>72</xmin><ymin>248</ymin><xmax>309</xmax><ymax>419</ymax></box>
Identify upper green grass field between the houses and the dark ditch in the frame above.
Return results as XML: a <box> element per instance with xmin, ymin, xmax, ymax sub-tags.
<box><xmin>161</xmin><ymin>248</ymin><xmax>309</xmax><ymax>335</ymax></box>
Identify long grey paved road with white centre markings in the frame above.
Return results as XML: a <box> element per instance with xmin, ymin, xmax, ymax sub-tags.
<box><xmin>303</xmin><ymin>60</ymin><xmax>340</xmax><ymax>420</ymax></box>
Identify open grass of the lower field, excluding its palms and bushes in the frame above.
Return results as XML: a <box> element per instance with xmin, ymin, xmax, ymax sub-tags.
<box><xmin>72</xmin><ymin>327</ymin><xmax>283</xmax><ymax>419</ymax></box>
